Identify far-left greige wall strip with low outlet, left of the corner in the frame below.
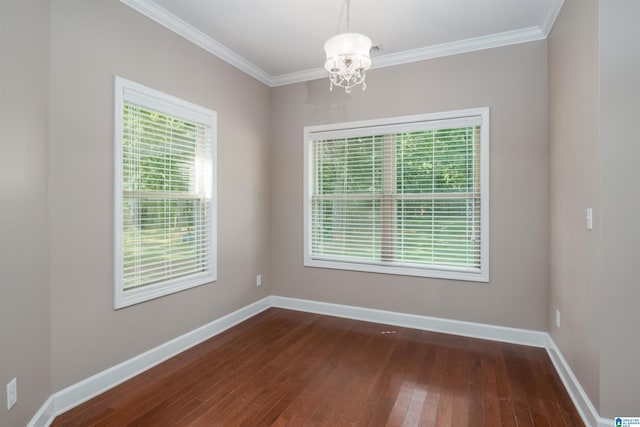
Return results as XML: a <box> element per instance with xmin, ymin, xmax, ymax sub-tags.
<box><xmin>0</xmin><ymin>0</ymin><xmax>51</xmax><ymax>427</ymax></box>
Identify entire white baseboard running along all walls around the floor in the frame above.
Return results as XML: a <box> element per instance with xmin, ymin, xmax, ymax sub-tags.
<box><xmin>27</xmin><ymin>295</ymin><xmax>614</xmax><ymax>427</ymax></box>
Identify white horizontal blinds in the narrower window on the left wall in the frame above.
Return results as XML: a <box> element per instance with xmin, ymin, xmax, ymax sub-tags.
<box><xmin>121</xmin><ymin>102</ymin><xmax>213</xmax><ymax>290</ymax></box>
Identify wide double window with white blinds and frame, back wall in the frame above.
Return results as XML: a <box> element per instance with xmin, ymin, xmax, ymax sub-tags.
<box><xmin>304</xmin><ymin>108</ymin><xmax>489</xmax><ymax>282</ymax></box>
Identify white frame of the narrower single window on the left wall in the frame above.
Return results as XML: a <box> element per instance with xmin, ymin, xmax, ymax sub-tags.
<box><xmin>114</xmin><ymin>76</ymin><xmax>217</xmax><ymax>309</ymax></box>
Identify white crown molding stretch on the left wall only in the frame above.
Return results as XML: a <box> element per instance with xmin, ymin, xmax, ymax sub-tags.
<box><xmin>120</xmin><ymin>0</ymin><xmax>273</xmax><ymax>86</ymax></box>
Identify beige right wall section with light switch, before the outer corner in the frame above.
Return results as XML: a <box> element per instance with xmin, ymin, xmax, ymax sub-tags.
<box><xmin>548</xmin><ymin>0</ymin><xmax>602</xmax><ymax>407</ymax></box>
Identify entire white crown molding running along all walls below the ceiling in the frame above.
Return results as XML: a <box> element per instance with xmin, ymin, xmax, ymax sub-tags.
<box><xmin>120</xmin><ymin>0</ymin><xmax>564</xmax><ymax>87</ymax></box>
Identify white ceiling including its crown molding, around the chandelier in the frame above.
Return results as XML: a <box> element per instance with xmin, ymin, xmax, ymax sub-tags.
<box><xmin>121</xmin><ymin>0</ymin><xmax>564</xmax><ymax>86</ymax></box>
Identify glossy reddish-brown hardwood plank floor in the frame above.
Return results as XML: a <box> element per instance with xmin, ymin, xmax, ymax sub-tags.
<box><xmin>52</xmin><ymin>308</ymin><xmax>584</xmax><ymax>427</ymax></box>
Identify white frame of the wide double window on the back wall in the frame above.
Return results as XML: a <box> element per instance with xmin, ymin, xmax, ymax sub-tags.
<box><xmin>303</xmin><ymin>107</ymin><xmax>490</xmax><ymax>282</ymax></box>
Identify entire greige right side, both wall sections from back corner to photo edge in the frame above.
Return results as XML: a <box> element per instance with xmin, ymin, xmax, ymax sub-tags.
<box><xmin>549</xmin><ymin>0</ymin><xmax>640</xmax><ymax>418</ymax></box>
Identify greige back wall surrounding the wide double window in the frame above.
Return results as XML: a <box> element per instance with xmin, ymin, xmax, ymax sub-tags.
<box><xmin>270</xmin><ymin>41</ymin><xmax>548</xmax><ymax>330</ymax></box>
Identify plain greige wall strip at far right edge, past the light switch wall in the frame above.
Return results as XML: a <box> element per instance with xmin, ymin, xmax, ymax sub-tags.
<box><xmin>599</xmin><ymin>0</ymin><xmax>640</xmax><ymax>418</ymax></box>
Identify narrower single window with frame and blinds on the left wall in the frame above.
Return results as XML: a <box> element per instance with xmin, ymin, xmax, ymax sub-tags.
<box><xmin>114</xmin><ymin>77</ymin><xmax>216</xmax><ymax>308</ymax></box>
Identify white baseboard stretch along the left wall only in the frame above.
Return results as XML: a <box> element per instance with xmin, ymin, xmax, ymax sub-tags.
<box><xmin>27</xmin><ymin>297</ymin><xmax>271</xmax><ymax>427</ymax></box>
